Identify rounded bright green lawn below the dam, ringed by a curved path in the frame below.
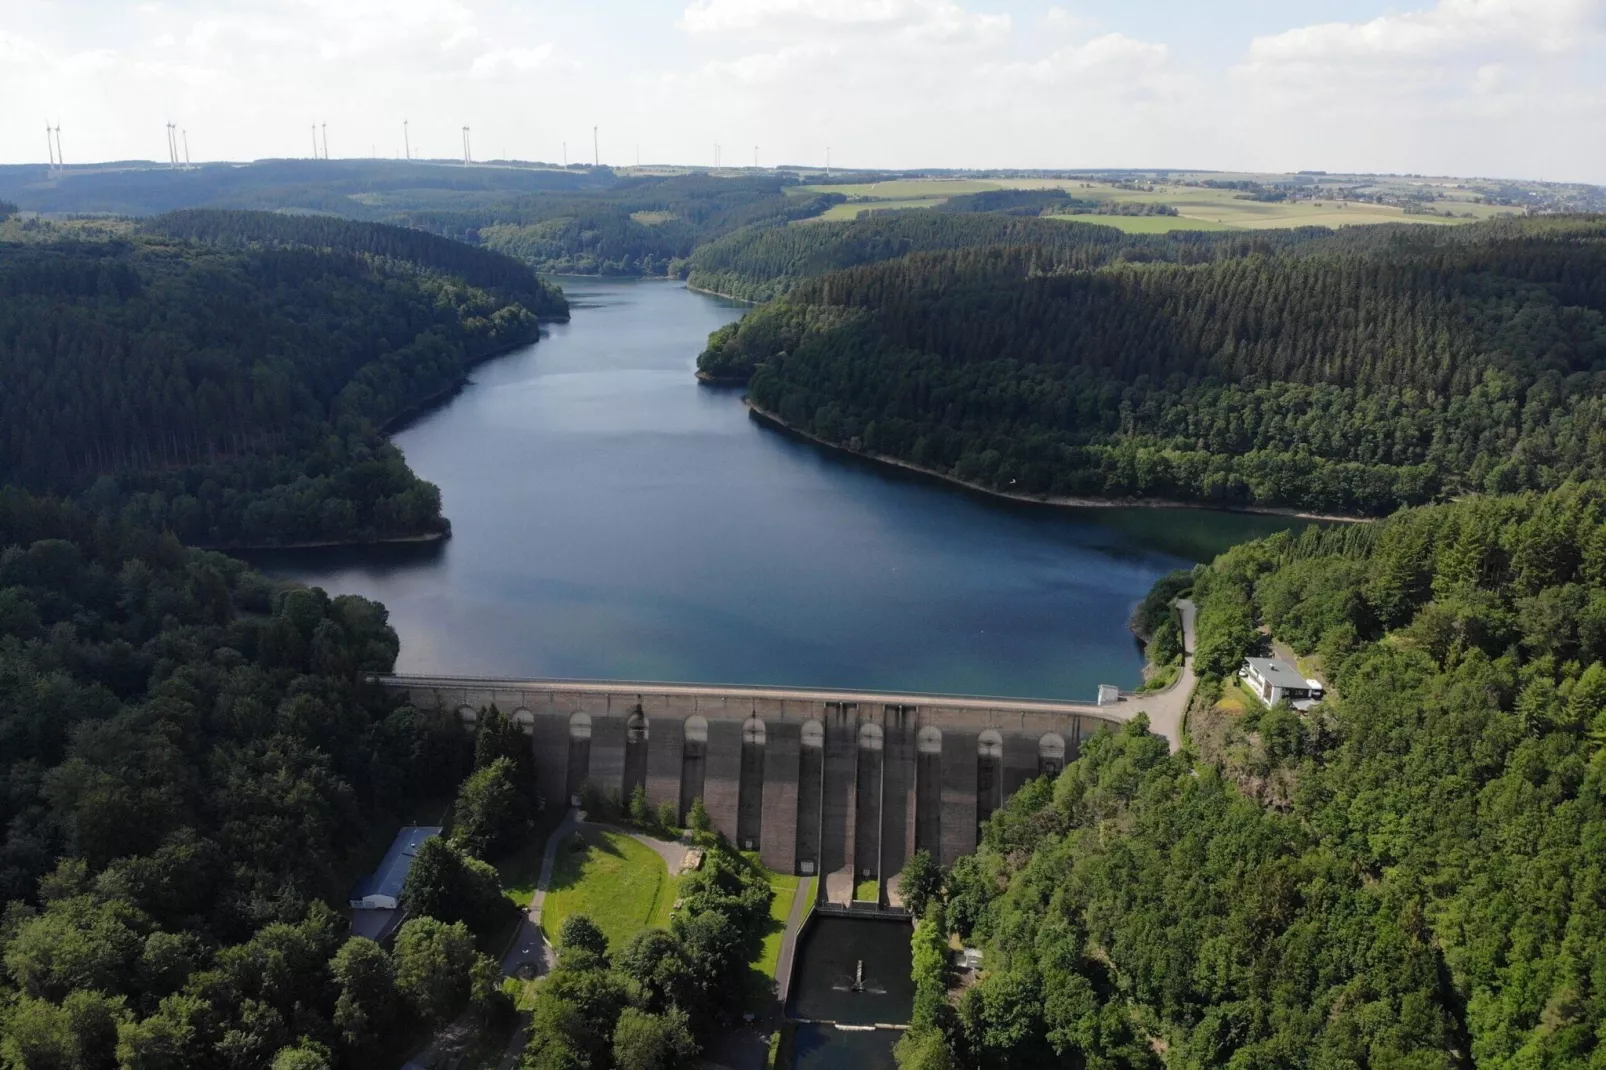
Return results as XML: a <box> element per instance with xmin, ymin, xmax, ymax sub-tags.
<box><xmin>541</xmin><ymin>829</ymin><xmax>679</xmax><ymax>948</ymax></box>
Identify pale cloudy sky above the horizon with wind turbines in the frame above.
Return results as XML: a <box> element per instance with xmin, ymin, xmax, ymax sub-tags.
<box><xmin>0</xmin><ymin>0</ymin><xmax>1606</xmax><ymax>183</ymax></box>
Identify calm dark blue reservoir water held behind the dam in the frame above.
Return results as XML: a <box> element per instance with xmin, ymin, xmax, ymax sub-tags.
<box><xmin>254</xmin><ymin>280</ymin><xmax>1288</xmax><ymax>699</ymax></box>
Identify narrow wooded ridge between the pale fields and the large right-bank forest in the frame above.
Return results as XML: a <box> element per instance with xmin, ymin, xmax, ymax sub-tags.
<box><xmin>689</xmin><ymin>210</ymin><xmax>1336</xmax><ymax>300</ymax></box>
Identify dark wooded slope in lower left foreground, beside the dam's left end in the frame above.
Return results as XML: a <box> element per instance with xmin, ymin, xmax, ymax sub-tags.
<box><xmin>0</xmin><ymin>487</ymin><xmax>498</xmax><ymax>1070</ymax></box>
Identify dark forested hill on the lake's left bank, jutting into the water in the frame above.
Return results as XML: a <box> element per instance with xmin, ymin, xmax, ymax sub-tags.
<box><xmin>0</xmin><ymin>212</ymin><xmax>567</xmax><ymax>545</ymax></box>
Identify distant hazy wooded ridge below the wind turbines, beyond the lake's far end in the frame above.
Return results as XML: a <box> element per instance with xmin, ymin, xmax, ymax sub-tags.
<box><xmin>0</xmin><ymin>159</ymin><xmax>842</xmax><ymax>275</ymax></box>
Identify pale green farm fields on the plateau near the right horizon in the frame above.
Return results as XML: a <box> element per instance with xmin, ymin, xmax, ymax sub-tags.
<box><xmin>797</xmin><ymin>175</ymin><xmax>1513</xmax><ymax>235</ymax></box>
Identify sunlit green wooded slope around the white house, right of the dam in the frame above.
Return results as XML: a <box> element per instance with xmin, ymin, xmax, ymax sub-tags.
<box><xmin>901</xmin><ymin>484</ymin><xmax>1606</xmax><ymax>1070</ymax></box>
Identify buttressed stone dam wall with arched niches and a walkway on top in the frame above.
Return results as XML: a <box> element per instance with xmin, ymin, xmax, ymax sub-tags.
<box><xmin>382</xmin><ymin>676</ymin><xmax>1142</xmax><ymax>906</ymax></box>
